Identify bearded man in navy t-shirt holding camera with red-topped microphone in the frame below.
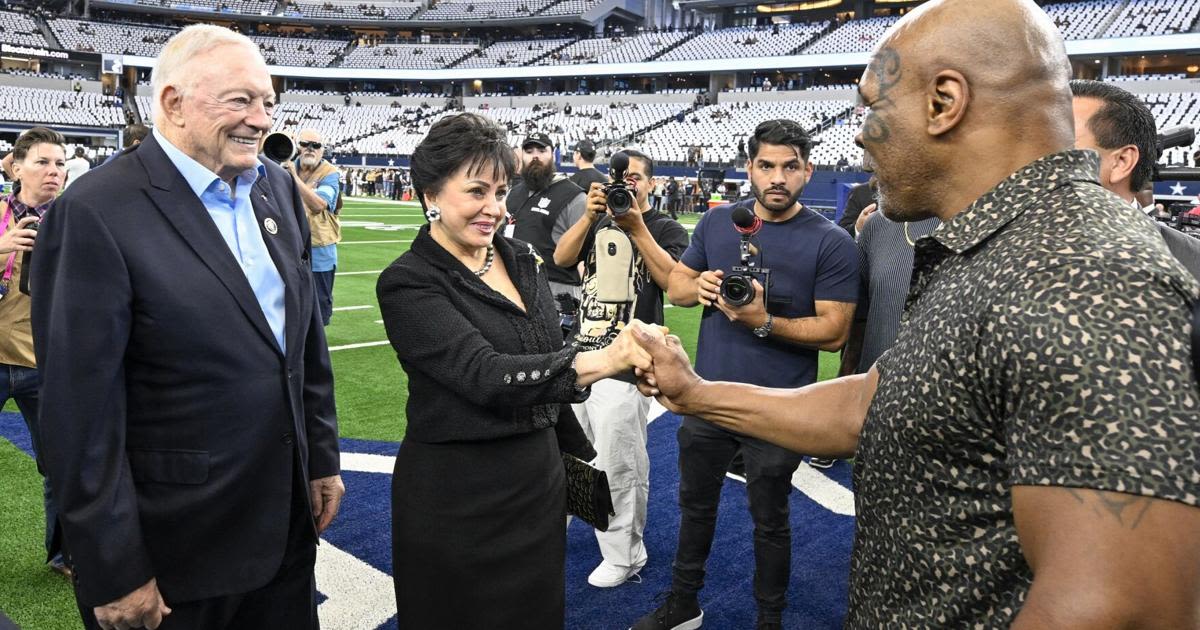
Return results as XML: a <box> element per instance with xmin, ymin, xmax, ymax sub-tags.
<box><xmin>634</xmin><ymin>120</ymin><xmax>859</xmax><ymax>630</ymax></box>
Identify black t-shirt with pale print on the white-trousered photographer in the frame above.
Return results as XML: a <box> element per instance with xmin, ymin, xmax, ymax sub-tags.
<box><xmin>575</xmin><ymin>210</ymin><xmax>688</xmax><ymax>352</ymax></box>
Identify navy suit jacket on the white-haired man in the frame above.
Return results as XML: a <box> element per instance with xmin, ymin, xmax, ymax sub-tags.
<box><xmin>31</xmin><ymin>137</ymin><xmax>338</xmax><ymax>606</ymax></box>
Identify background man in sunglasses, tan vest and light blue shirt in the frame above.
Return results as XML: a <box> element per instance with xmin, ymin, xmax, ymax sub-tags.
<box><xmin>282</xmin><ymin>130</ymin><xmax>342</xmax><ymax>326</ymax></box>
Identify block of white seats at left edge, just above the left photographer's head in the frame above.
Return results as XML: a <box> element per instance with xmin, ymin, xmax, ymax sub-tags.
<box><xmin>0</xmin><ymin>85</ymin><xmax>125</xmax><ymax>127</ymax></box>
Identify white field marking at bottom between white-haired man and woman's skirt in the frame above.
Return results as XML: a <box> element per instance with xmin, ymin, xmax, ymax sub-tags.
<box><xmin>316</xmin><ymin>535</ymin><xmax>396</xmax><ymax>630</ymax></box>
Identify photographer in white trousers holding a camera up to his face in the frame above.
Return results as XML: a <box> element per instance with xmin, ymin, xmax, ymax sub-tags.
<box><xmin>554</xmin><ymin>150</ymin><xmax>688</xmax><ymax>588</ymax></box>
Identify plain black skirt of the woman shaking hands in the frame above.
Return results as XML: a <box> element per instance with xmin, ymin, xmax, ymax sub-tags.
<box><xmin>391</xmin><ymin>428</ymin><xmax>566</xmax><ymax>630</ymax></box>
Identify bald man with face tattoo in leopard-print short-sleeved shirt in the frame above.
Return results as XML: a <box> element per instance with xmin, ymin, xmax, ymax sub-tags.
<box><xmin>641</xmin><ymin>0</ymin><xmax>1200</xmax><ymax>630</ymax></box>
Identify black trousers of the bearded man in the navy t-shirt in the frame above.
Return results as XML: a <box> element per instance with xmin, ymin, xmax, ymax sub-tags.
<box><xmin>671</xmin><ymin>416</ymin><xmax>802</xmax><ymax>620</ymax></box>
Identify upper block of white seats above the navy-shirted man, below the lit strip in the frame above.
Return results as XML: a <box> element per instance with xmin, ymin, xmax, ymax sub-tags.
<box><xmin>660</xmin><ymin>20</ymin><xmax>829</xmax><ymax>61</ymax></box>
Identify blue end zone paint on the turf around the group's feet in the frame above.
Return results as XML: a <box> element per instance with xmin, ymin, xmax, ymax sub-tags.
<box><xmin>0</xmin><ymin>413</ymin><xmax>854</xmax><ymax>630</ymax></box>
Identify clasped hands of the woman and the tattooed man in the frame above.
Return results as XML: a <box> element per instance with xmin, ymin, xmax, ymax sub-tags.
<box><xmin>606</xmin><ymin>319</ymin><xmax>701</xmax><ymax>414</ymax></box>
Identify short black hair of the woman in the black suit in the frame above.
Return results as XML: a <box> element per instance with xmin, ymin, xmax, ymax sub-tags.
<box><xmin>410</xmin><ymin>114</ymin><xmax>517</xmax><ymax>208</ymax></box>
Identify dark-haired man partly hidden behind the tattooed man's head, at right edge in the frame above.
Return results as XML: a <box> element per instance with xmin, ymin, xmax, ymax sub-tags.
<box><xmin>1070</xmin><ymin>80</ymin><xmax>1200</xmax><ymax>280</ymax></box>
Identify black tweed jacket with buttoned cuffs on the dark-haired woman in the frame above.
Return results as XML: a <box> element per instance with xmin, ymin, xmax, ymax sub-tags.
<box><xmin>376</xmin><ymin>226</ymin><xmax>595</xmax><ymax>461</ymax></box>
